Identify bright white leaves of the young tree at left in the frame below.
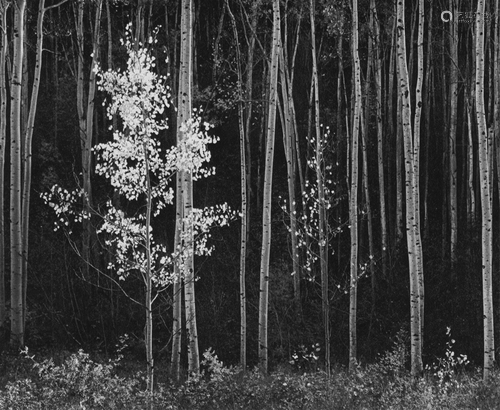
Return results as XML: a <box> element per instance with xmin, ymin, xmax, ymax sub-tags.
<box><xmin>42</xmin><ymin>26</ymin><xmax>236</xmax><ymax>287</ymax></box>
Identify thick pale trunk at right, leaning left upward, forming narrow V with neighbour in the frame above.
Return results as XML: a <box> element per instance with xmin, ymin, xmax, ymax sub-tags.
<box><xmin>397</xmin><ymin>0</ymin><xmax>423</xmax><ymax>377</ymax></box>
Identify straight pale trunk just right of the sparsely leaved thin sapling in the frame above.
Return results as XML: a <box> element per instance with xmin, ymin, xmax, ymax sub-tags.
<box><xmin>348</xmin><ymin>0</ymin><xmax>362</xmax><ymax>371</ymax></box>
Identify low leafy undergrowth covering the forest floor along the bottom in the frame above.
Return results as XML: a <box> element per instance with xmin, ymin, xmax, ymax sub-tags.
<box><xmin>0</xmin><ymin>344</ymin><xmax>500</xmax><ymax>410</ymax></box>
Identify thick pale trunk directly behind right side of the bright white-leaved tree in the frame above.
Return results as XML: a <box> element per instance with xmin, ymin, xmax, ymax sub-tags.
<box><xmin>177</xmin><ymin>0</ymin><xmax>200</xmax><ymax>375</ymax></box>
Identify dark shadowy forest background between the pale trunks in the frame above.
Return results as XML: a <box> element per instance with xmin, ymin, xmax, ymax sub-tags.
<box><xmin>0</xmin><ymin>0</ymin><xmax>494</xmax><ymax>374</ymax></box>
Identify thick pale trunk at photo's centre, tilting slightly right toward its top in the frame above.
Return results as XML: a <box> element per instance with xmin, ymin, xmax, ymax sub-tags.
<box><xmin>258</xmin><ymin>0</ymin><xmax>281</xmax><ymax>373</ymax></box>
